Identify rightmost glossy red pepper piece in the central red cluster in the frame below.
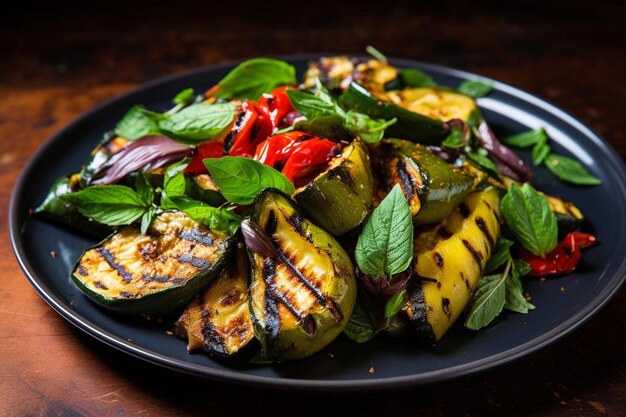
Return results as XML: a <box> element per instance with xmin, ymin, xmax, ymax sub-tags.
<box><xmin>282</xmin><ymin>138</ymin><xmax>338</xmax><ymax>182</ymax></box>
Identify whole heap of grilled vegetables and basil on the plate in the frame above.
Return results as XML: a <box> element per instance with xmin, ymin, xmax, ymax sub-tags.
<box><xmin>35</xmin><ymin>49</ymin><xmax>600</xmax><ymax>361</ymax></box>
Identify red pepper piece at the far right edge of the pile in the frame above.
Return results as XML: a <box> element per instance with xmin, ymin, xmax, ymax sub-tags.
<box><xmin>520</xmin><ymin>232</ymin><xmax>597</xmax><ymax>277</ymax></box>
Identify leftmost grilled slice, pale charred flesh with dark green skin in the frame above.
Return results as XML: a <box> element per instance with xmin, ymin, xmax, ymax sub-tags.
<box><xmin>72</xmin><ymin>211</ymin><xmax>233</xmax><ymax>315</ymax></box>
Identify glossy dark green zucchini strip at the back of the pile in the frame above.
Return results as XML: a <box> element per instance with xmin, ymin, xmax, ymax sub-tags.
<box><xmin>339</xmin><ymin>82</ymin><xmax>449</xmax><ymax>145</ymax></box>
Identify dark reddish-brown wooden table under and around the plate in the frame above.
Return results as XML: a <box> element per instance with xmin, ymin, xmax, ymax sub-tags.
<box><xmin>0</xmin><ymin>1</ymin><xmax>626</xmax><ymax>416</ymax></box>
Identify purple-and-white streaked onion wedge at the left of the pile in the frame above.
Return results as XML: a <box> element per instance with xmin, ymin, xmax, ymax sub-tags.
<box><xmin>89</xmin><ymin>135</ymin><xmax>193</xmax><ymax>185</ymax></box>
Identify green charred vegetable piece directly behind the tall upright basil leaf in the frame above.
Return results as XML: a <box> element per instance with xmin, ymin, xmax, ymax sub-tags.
<box><xmin>375</xmin><ymin>139</ymin><xmax>474</xmax><ymax>224</ymax></box>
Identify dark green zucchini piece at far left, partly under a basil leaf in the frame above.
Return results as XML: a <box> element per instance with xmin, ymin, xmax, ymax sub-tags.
<box><xmin>34</xmin><ymin>173</ymin><xmax>113</xmax><ymax>239</ymax></box>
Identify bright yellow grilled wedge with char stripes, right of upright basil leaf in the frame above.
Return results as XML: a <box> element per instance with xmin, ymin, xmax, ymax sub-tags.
<box><xmin>404</xmin><ymin>188</ymin><xmax>500</xmax><ymax>343</ymax></box>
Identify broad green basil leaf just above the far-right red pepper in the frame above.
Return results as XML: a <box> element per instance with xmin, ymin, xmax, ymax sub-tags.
<box><xmin>500</xmin><ymin>183</ymin><xmax>557</xmax><ymax>257</ymax></box>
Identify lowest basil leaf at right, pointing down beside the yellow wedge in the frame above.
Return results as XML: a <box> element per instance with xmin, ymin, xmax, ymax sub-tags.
<box><xmin>465</xmin><ymin>271</ymin><xmax>507</xmax><ymax>330</ymax></box>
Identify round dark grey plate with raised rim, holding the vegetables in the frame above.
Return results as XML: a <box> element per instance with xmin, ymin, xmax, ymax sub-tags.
<box><xmin>9</xmin><ymin>56</ymin><xmax>626</xmax><ymax>390</ymax></box>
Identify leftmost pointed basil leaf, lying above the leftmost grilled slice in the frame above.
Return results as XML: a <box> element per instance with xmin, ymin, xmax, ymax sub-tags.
<box><xmin>60</xmin><ymin>185</ymin><xmax>149</xmax><ymax>226</ymax></box>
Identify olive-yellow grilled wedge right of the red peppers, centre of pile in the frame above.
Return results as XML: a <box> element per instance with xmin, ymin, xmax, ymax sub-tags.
<box><xmin>293</xmin><ymin>139</ymin><xmax>374</xmax><ymax>232</ymax></box>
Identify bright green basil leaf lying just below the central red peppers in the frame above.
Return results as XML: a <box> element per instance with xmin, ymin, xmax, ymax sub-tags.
<box><xmin>203</xmin><ymin>156</ymin><xmax>295</xmax><ymax>204</ymax></box>
